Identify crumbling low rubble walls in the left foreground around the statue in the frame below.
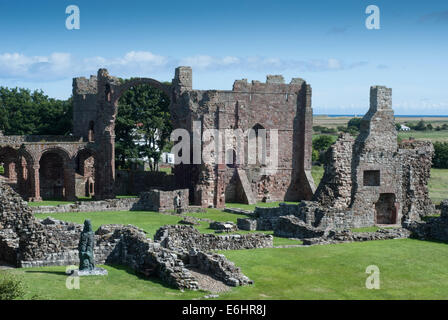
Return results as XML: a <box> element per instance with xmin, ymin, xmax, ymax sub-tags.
<box><xmin>0</xmin><ymin>183</ymin><xmax>272</xmax><ymax>290</ymax></box>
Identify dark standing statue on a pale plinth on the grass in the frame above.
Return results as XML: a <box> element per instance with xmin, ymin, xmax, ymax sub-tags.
<box><xmin>67</xmin><ymin>219</ymin><xmax>107</xmax><ymax>277</ymax></box>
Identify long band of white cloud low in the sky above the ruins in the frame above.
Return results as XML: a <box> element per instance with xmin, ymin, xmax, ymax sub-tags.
<box><xmin>0</xmin><ymin>51</ymin><xmax>366</xmax><ymax>81</ymax></box>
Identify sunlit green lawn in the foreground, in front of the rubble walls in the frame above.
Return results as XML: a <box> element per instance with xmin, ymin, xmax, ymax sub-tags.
<box><xmin>3</xmin><ymin>239</ymin><xmax>448</xmax><ymax>299</ymax></box>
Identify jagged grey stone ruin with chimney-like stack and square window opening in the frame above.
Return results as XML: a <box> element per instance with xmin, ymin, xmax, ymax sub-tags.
<box><xmin>239</xmin><ymin>86</ymin><xmax>435</xmax><ymax>236</ymax></box>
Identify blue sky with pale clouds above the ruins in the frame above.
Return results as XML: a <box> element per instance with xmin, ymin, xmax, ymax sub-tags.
<box><xmin>0</xmin><ymin>0</ymin><xmax>448</xmax><ymax>115</ymax></box>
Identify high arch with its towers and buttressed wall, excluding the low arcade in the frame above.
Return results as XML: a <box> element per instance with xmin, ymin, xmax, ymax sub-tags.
<box><xmin>73</xmin><ymin>67</ymin><xmax>315</xmax><ymax>207</ymax></box>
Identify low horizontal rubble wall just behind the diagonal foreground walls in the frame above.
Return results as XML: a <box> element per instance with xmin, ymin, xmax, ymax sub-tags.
<box><xmin>154</xmin><ymin>225</ymin><xmax>273</xmax><ymax>251</ymax></box>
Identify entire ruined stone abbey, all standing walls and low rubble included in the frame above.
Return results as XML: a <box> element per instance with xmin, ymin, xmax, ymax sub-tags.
<box><xmin>0</xmin><ymin>67</ymin><xmax>448</xmax><ymax>289</ymax></box>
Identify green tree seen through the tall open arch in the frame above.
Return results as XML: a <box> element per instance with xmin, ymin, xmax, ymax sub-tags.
<box><xmin>115</xmin><ymin>85</ymin><xmax>172</xmax><ymax>170</ymax></box>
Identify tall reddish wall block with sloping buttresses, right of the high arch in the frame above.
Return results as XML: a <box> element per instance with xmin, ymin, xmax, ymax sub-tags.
<box><xmin>183</xmin><ymin>76</ymin><xmax>314</xmax><ymax>206</ymax></box>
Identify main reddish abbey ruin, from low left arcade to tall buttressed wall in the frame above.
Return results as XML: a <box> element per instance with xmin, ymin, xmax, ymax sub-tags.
<box><xmin>0</xmin><ymin>67</ymin><xmax>315</xmax><ymax>208</ymax></box>
